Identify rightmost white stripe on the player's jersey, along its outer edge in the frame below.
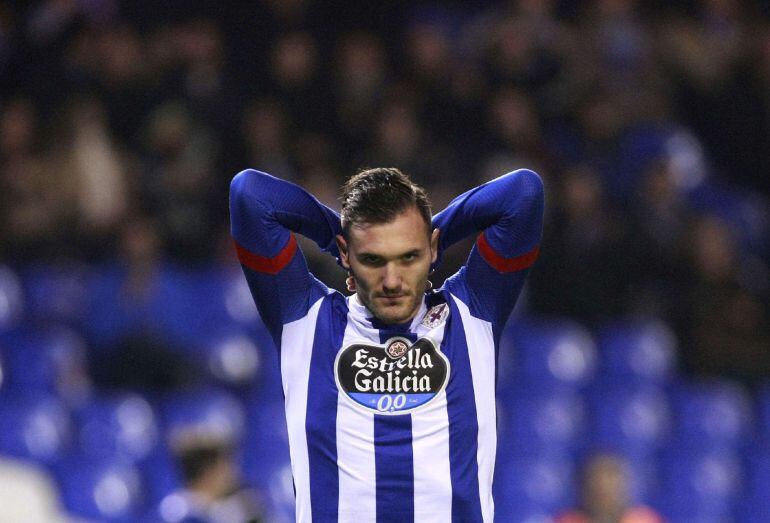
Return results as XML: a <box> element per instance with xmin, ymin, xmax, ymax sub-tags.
<box><xmin>452</xmin><ymin>295</ymin><xmax>497</xmax><ymax>523</ymax></box>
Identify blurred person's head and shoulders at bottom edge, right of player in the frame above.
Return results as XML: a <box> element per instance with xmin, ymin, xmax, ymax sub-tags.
<box><xmin>555</xmin><ymin>453</ymin><xmax>663</xmax><ymax>523</ymax></box>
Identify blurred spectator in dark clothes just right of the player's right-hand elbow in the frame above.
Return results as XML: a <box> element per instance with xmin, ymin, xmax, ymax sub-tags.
<box><xmin>530</xmin><ymin>166</ymin><xmax>643</xmax><ymax>326</ymax></box>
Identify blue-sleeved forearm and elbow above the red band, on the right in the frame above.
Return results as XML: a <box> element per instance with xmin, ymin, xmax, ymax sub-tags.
<box><xmin>433</xmin><ymin>169</ymin><xmax>543</xmax><ymax>257</ymax></box>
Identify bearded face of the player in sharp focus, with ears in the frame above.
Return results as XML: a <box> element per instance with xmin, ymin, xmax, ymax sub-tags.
<box><xmin>337</xmin><ymin>207</ymin><xmax>438</xmax><ymax>323</ymax></box>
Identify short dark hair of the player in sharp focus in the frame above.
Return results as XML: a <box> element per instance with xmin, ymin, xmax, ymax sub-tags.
<box><xmin>340</xmin><ymin>167</ymin><xmax>432</xmax><ymax>237</ymax></box>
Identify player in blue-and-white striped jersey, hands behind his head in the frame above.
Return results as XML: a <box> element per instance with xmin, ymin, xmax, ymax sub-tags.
<box><xmin>230</xmin><ymin>168</ymin><xmax>543</xmax><ymax>522</ymax></box>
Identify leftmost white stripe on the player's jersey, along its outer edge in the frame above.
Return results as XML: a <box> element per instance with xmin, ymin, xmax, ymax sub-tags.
<box><xmin>281</xmin><ymin>298</ymin><xmax>324</xmax><ymax>521</ymax></box>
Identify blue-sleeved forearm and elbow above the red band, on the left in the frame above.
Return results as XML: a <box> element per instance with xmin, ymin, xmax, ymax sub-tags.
<box><xmin>230</xmin><ymin>169</ymin><xmax>340</xmax><ymax>257</ymax></box>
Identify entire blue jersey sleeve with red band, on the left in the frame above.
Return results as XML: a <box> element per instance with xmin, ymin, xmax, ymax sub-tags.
<box><xmin>230</xmin><ymin>169</ymin><xmax>341</xmax><ymax>345</ymax></box>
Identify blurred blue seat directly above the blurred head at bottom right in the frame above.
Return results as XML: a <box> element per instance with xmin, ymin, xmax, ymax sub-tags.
<box><xmin>588</xmin><ymin>382</ymin><xmax>672</xmax><ymax>457</ymax></box>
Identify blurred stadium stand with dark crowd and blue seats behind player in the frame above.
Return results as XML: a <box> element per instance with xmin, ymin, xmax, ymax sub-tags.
<box><xmin>0</xmin><ymin>0</ymin><xmax>770</xmax><ymax>523</ymax></box>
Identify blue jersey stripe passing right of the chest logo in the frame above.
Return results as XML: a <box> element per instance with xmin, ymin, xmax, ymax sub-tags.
<box><xmin>441</xmin><ymin>292</ymin><xmax>483</xmax><ymax>523</ymax></box>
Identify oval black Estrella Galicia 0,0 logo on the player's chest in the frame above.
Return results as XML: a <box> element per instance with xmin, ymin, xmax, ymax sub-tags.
<box><xmin>334</xmin><ymin>338</ymin><xmax>449</xmax><ymax>414</ymax></box>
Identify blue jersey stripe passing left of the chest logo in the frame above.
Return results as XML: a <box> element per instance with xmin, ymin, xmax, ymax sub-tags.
<box><xmin>305</xmin><ymin>294</ymin><xmax>347</xmax><ymax>521</ymax></box>
